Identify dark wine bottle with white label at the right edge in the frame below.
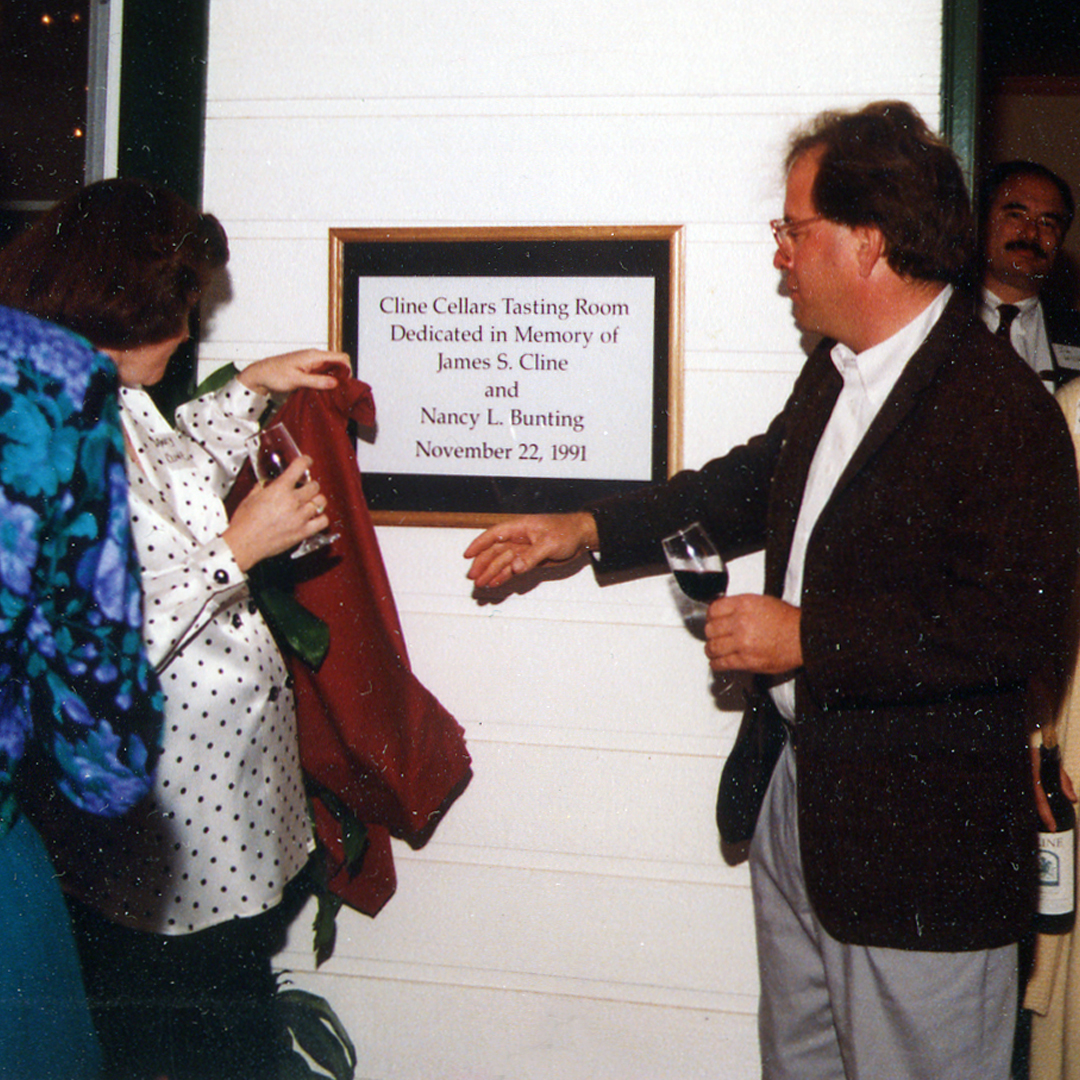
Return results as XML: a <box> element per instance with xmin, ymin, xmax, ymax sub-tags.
<box><xmin>1035</xmin><ymin>728</ymin><xmax>1077</xmax><ymax>934</ymax></box>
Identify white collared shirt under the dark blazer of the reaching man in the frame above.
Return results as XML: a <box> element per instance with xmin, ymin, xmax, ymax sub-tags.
<box><xmin>771</xmin><ymin>285</ymin><xmax>953</xmax><ymax>720</ymax></box>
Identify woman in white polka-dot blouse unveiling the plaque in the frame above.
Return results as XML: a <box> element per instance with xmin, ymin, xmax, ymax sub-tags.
<box><xmin>0</xmin><ymin>180</ymin><xmax>349</xmax><ymax>1080</ymax></box>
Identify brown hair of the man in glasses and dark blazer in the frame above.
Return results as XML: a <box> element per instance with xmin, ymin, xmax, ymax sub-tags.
<box><xmin>787</xmin><ymin>102</ymin><xmax>975</xmax><ymax>284</ymax></box>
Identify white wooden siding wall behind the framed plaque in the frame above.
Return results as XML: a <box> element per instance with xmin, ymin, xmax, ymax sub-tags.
<box><xmin>202</xmin><ymin>0</ymin><xmax>941</xmax><ymax>1080</ymax></box>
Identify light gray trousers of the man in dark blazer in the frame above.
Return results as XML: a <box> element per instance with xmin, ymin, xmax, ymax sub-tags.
<box><xmin>750</xmin><ymin>745</ymin><xmax>1017</xmax><ymax>1080</ymax></box>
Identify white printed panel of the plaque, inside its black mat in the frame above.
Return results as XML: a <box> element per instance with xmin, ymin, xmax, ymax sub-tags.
<box><xmin>356</xmin><ymin>276</ymin><xmax>657</xmax><ymax>483</ymax></box>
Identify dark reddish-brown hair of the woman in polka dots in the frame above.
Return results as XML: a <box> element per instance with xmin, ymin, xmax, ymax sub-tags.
<box><xmin>0</xmin><ymin>179</ymin><xmax>229</xmax><ymax>349</ymax></box>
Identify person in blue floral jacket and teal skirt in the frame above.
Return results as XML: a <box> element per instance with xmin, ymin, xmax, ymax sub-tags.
<box><xmin>0</xmin><ymin>308</ymin><xmax>162</xmax><ymax>1080</ymax></box>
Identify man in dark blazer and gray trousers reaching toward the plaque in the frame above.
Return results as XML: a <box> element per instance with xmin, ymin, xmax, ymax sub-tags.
<box><xmin>465</xmin><ymin>102</ymin><xmax>1080</xmax><ymax>1080</ymax></box>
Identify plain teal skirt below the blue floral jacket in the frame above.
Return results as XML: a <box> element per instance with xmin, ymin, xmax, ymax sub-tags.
<box><xmin>0</xmin><ymin>815</ymin><xmax>100</xmax><ymax>1080</ymax></box>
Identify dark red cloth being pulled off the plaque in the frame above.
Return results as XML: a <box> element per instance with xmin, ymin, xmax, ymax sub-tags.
<box><xmin>235</xmin><ymin>379</ymin><xmax>471</xmax><ymax>916</ymax></box>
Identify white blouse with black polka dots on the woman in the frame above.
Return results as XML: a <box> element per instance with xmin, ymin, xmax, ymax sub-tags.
<box><xmin>55</xmin><ymin>380</ymin><xmax>312</xmax><ymax>934</ymax></box>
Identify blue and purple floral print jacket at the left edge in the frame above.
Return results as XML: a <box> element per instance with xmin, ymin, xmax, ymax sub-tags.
<box><xmin>0</xmin><ymin>308</ymin><xmax>163</xmax><ymax>835</ymax></box>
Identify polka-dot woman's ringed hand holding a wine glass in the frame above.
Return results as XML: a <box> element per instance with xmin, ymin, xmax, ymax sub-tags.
<box><xmin>221</xmin><ymin>455</ymin><xmax>329</xmax><ymax>572</ymax></box>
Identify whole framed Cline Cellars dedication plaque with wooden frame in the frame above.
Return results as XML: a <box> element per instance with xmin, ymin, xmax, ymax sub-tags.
<box><xmin>330</xmin><ymin>225</ymin><xmax>683</xmax><ymax>527</ymax></box>
